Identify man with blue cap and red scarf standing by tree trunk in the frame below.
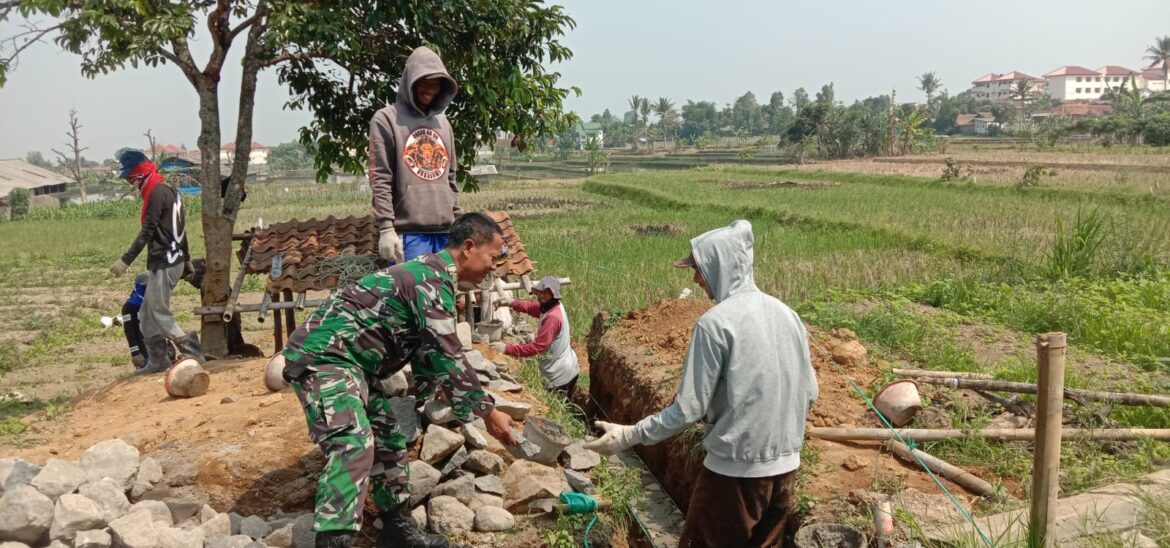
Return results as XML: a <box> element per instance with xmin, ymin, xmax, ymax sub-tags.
<box><xmin>110</xmin><ymin>150</ymin><xmax>204</xmax><ymax>375</ymax></box>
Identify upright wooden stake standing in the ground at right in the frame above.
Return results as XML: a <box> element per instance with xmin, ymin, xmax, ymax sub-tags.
<box><xmin>1028</xmin><ymin>333</ymin><xmax>1067</xmax><ymax>548</ymax></box>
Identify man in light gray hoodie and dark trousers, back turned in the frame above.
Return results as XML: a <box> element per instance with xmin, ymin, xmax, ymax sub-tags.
<box><xmin>585</xmin><ymin>220</ymin><xmax>818</xmax><ymax>547</ymax></box>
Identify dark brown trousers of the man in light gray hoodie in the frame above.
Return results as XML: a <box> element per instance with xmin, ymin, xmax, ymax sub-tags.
<box><xmin>679</xmin><ymin>466</ymin><xmax>797</xmax><ymax>548</ymax></box>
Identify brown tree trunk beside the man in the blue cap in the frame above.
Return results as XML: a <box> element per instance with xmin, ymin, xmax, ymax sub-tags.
<box><xmin>195</xmin><ymin>78</ymin><xmax>232</xmax><ymax>357</ymax></box>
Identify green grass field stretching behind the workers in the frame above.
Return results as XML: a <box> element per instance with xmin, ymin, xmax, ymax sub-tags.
<box><xmin>0</xmin><ymin>155</ymin><xmax>1170</xmax><ymax>538</ymax></box>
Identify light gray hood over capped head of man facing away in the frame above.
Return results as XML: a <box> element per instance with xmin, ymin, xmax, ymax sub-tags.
<box><xmin>677</xmin><ymin>219</ymin><xmax>758</xmax><ymax>302</ymax></box>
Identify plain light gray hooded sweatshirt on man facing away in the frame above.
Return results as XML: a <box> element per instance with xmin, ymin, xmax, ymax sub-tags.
<box><xmin>634</xmin><ymin>220</ymin><xmax>818</xmax><ymax>478</ymax></box>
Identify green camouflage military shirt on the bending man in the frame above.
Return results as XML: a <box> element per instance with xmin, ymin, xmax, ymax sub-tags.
<box><xmin>283</xmin><ymin>251</ymin><xmax>494</xmax><ymax>423</ymax></box>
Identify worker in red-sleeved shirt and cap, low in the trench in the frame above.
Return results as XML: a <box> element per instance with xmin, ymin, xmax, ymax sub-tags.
<box><xmin>491</xmin><ymin>276</ymin><xmax>580</xmax><ymax>400</ymax></box>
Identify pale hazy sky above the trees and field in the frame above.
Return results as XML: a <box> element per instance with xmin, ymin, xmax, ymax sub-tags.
<box><xmin>0</xmin><ymin>0</ymin><xmax>1170</xmax><ymax>159</ymax></box>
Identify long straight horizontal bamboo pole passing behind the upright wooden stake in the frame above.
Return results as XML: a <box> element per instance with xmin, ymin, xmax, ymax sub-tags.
<box><xmin>805</xmin><ymin>427</ymin><xmax>1170</xmax><ymax>441</ymax></box>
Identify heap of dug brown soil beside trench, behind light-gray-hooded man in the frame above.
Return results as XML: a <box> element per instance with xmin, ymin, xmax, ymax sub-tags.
<box><xmin>589</xmin><ymin>300</ymin><xmax>978</xmax><ymax>515</ymax></box>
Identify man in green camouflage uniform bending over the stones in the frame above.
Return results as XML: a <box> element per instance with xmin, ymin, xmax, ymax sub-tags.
<box><xmin>283</xmin><ymin>213</ymin><xmax>516</xmax><ymax>548</ymax></box>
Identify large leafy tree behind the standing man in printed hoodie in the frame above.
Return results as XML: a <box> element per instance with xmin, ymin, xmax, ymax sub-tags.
<box><xmin>0</xmin><ymin>0</ymin><xmax>576</xmax><ymax>355</ymax></box>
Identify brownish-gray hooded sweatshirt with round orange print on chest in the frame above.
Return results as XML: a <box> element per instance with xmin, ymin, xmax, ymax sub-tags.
<box><xmin>370</xmin><ymin>47</ymin><xmax>462</xmax><ymax>234</ymax></box>
